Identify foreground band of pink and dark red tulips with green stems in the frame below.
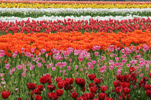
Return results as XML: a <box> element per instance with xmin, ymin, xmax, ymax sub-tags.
<box><xmin>0</xmin><ymin>44</ymin><xmax>151</xmax><ymax>100</ymax></box>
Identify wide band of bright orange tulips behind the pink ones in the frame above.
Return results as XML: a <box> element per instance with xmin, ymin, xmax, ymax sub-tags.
<box><xmin>0</xmin><ymin>30</ymin><xmax>151</xmax><ymax>56</ymax></box>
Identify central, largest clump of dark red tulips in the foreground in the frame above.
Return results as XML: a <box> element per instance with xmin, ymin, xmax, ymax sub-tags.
<box><xmin>27</xmin><ymin>74</ymin><xmax>113</xmax><ymax>100</ymax></box>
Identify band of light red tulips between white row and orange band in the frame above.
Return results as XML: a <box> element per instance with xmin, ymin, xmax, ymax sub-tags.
<box><xmin>0</xmin><ymin>18</ymin><xmax>151</xmax><ymax>33</ymax></box>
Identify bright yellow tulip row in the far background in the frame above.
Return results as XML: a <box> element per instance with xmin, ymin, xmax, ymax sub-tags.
<box><xmin>0</xmin><ymin>3</ymin><xmax>151</xmax><ymax>9</ymax></box>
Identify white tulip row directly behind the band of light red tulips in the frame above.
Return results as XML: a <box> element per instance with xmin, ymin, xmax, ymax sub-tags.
<box><xmin>0</xmin><ymin>15</ymin><xmax>151</xmax><ymax>22</ymax></box>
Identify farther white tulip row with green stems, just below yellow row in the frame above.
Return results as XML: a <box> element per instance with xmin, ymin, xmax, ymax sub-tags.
<box><xmin>0</xmin><ymin>8</ymin><xmax>151</xmax><ymax>18</ymax></box>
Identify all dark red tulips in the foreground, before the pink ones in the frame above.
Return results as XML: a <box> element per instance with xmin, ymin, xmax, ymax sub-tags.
<box><xmin>1</xmin><ymin>67</ymin><xmax>151</xmax><ymax>100</ymax></box>
